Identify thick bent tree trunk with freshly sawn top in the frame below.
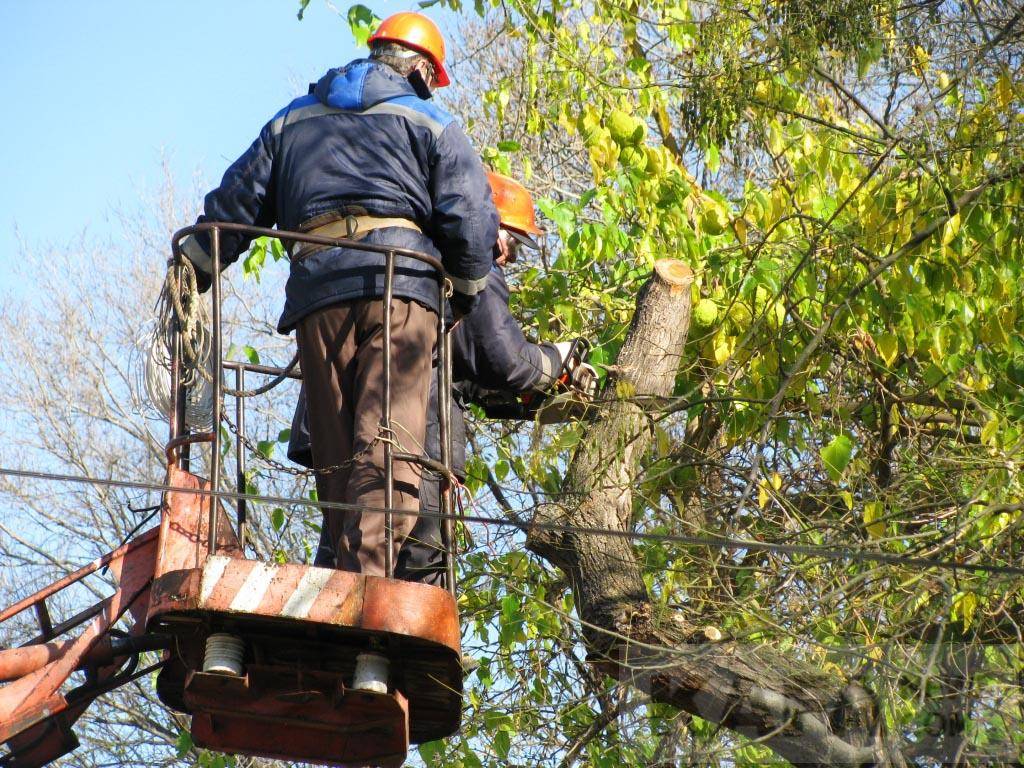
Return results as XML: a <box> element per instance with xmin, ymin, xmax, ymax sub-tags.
<box><xmin>527</xmin><ymin>259</ymin><xmax>885</xmax><ymax>766</ymax></box>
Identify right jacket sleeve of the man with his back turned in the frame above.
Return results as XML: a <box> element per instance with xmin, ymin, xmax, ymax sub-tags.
<box><xmin>430</xmin><ymin>123</ymin><xmax>498</xmax><ymax>307</ymax></box>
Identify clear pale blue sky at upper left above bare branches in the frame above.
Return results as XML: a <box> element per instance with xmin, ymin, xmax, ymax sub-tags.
<box><xmin>0</xmin><ymin>0</ymin><xmax>430</xmax><ymax>290</ymax></box>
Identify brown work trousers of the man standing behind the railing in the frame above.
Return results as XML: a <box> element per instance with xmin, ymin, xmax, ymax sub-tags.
<box><xmin>296</xmin><ymin>299</ymin><xmax>437</xmax><ymax>575</ymax></box>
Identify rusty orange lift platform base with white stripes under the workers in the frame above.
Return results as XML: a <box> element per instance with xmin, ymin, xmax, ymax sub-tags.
<box><xmin>146</xmin><ymin>469</ymin><xmax>462</xmax><ymax>766</ymax></box>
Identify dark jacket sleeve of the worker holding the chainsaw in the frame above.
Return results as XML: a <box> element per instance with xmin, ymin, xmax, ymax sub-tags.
<box><xmin>453</xmin><ymin>271</ymin><xmax>561</xmax><ymax>393</ymax></box>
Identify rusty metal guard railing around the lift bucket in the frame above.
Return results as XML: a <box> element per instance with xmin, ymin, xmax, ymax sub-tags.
<box><xmin>166</xmin><ymin>221</ymin><xmax>456</xmax><ymax>594</ymax></box>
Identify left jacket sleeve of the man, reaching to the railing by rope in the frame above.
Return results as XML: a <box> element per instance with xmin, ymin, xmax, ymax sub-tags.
<box><xmin>181</xmin><ymin>123</ymin><xmax>276</xmax><ymax>280</ymax></box>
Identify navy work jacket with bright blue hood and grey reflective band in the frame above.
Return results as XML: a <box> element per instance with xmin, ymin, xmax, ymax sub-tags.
<box><xmin>182</xmin><ymin>59</ymin><xmax>498</xmax><ymax>333</ymax></box>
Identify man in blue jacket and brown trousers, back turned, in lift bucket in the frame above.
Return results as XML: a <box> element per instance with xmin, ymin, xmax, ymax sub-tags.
<box><xmin>182</xmin><ymin>13</ymin><xmax>498</xmax><ymax>575</ymax></box>
